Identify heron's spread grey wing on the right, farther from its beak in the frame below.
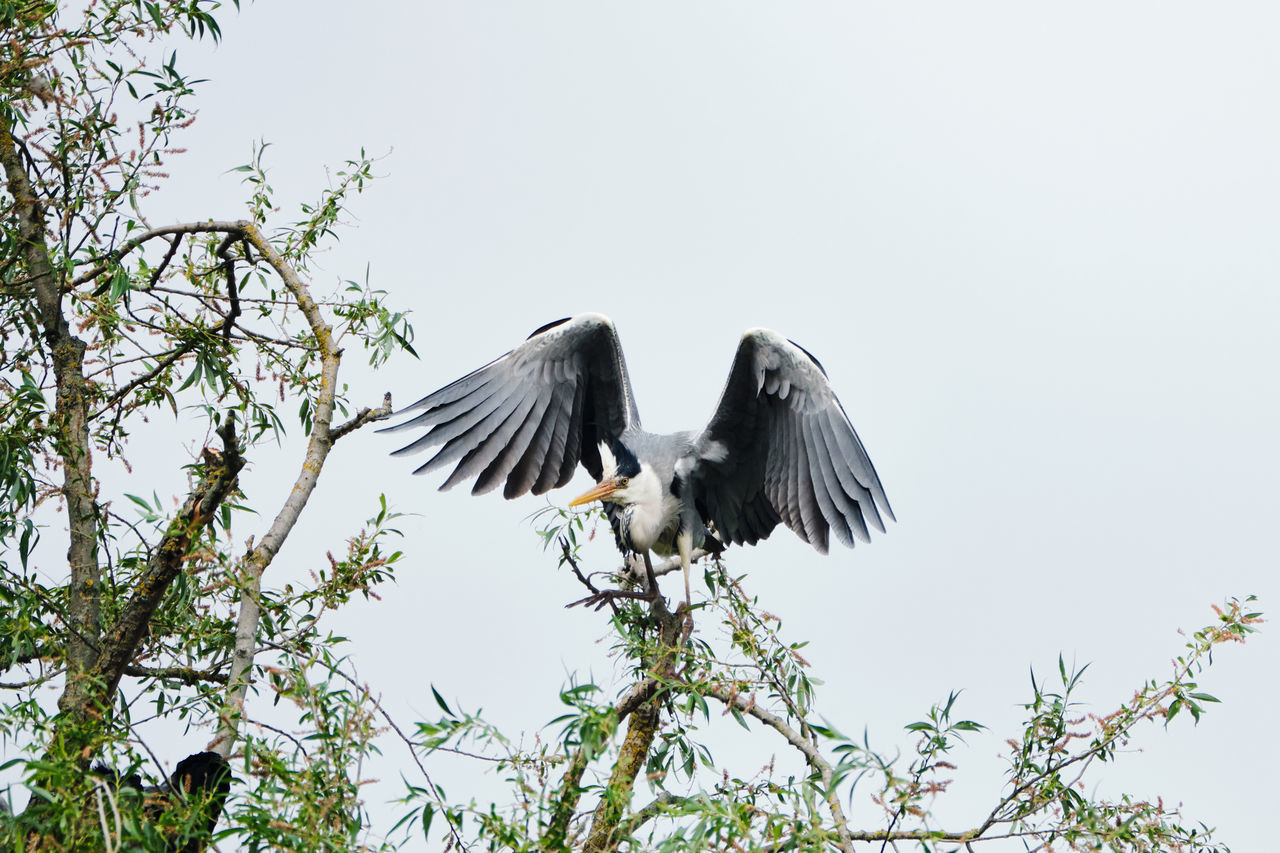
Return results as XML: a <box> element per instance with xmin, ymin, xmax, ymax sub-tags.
<box><xmin>689</xmin><ymin>329</ymin><xmax>893</xmax><ymax>553</ymax></box>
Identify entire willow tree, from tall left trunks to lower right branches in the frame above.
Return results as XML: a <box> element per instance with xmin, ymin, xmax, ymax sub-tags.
<box><xmin>0</xmin><ymin>0</ymin><xmax>1258</xmax><ymax>850</ymax></box>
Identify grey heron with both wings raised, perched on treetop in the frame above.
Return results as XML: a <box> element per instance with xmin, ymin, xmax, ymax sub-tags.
<box><xmin>379</xmin><ymin>314</ymin><xmax>895</xmax><ymax>606</ymax></box>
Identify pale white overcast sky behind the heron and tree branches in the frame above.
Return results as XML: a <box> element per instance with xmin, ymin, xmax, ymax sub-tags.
<box><xmin>80</xmin><ymin>0</ymin><xmax>1280</xmax><ymax>850</ymax></box>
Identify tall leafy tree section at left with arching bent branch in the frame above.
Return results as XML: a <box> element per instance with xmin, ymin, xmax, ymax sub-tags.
<box><xmin>0</xmin><ymin>0</ymin><xmax>411</xmax><ymax>849</ymax></box>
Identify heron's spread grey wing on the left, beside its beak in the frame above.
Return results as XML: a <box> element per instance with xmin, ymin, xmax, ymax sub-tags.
<box><xmin>380</xmin><ymin>314</ymin><xmax>640</xmax><ymax>498</ymax></box>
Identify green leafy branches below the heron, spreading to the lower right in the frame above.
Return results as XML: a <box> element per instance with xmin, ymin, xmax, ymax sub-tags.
<box><xmin>384</xmin><ymin>510</ymin><xmax>1261</xmax><ymax>850</ymax></box>
